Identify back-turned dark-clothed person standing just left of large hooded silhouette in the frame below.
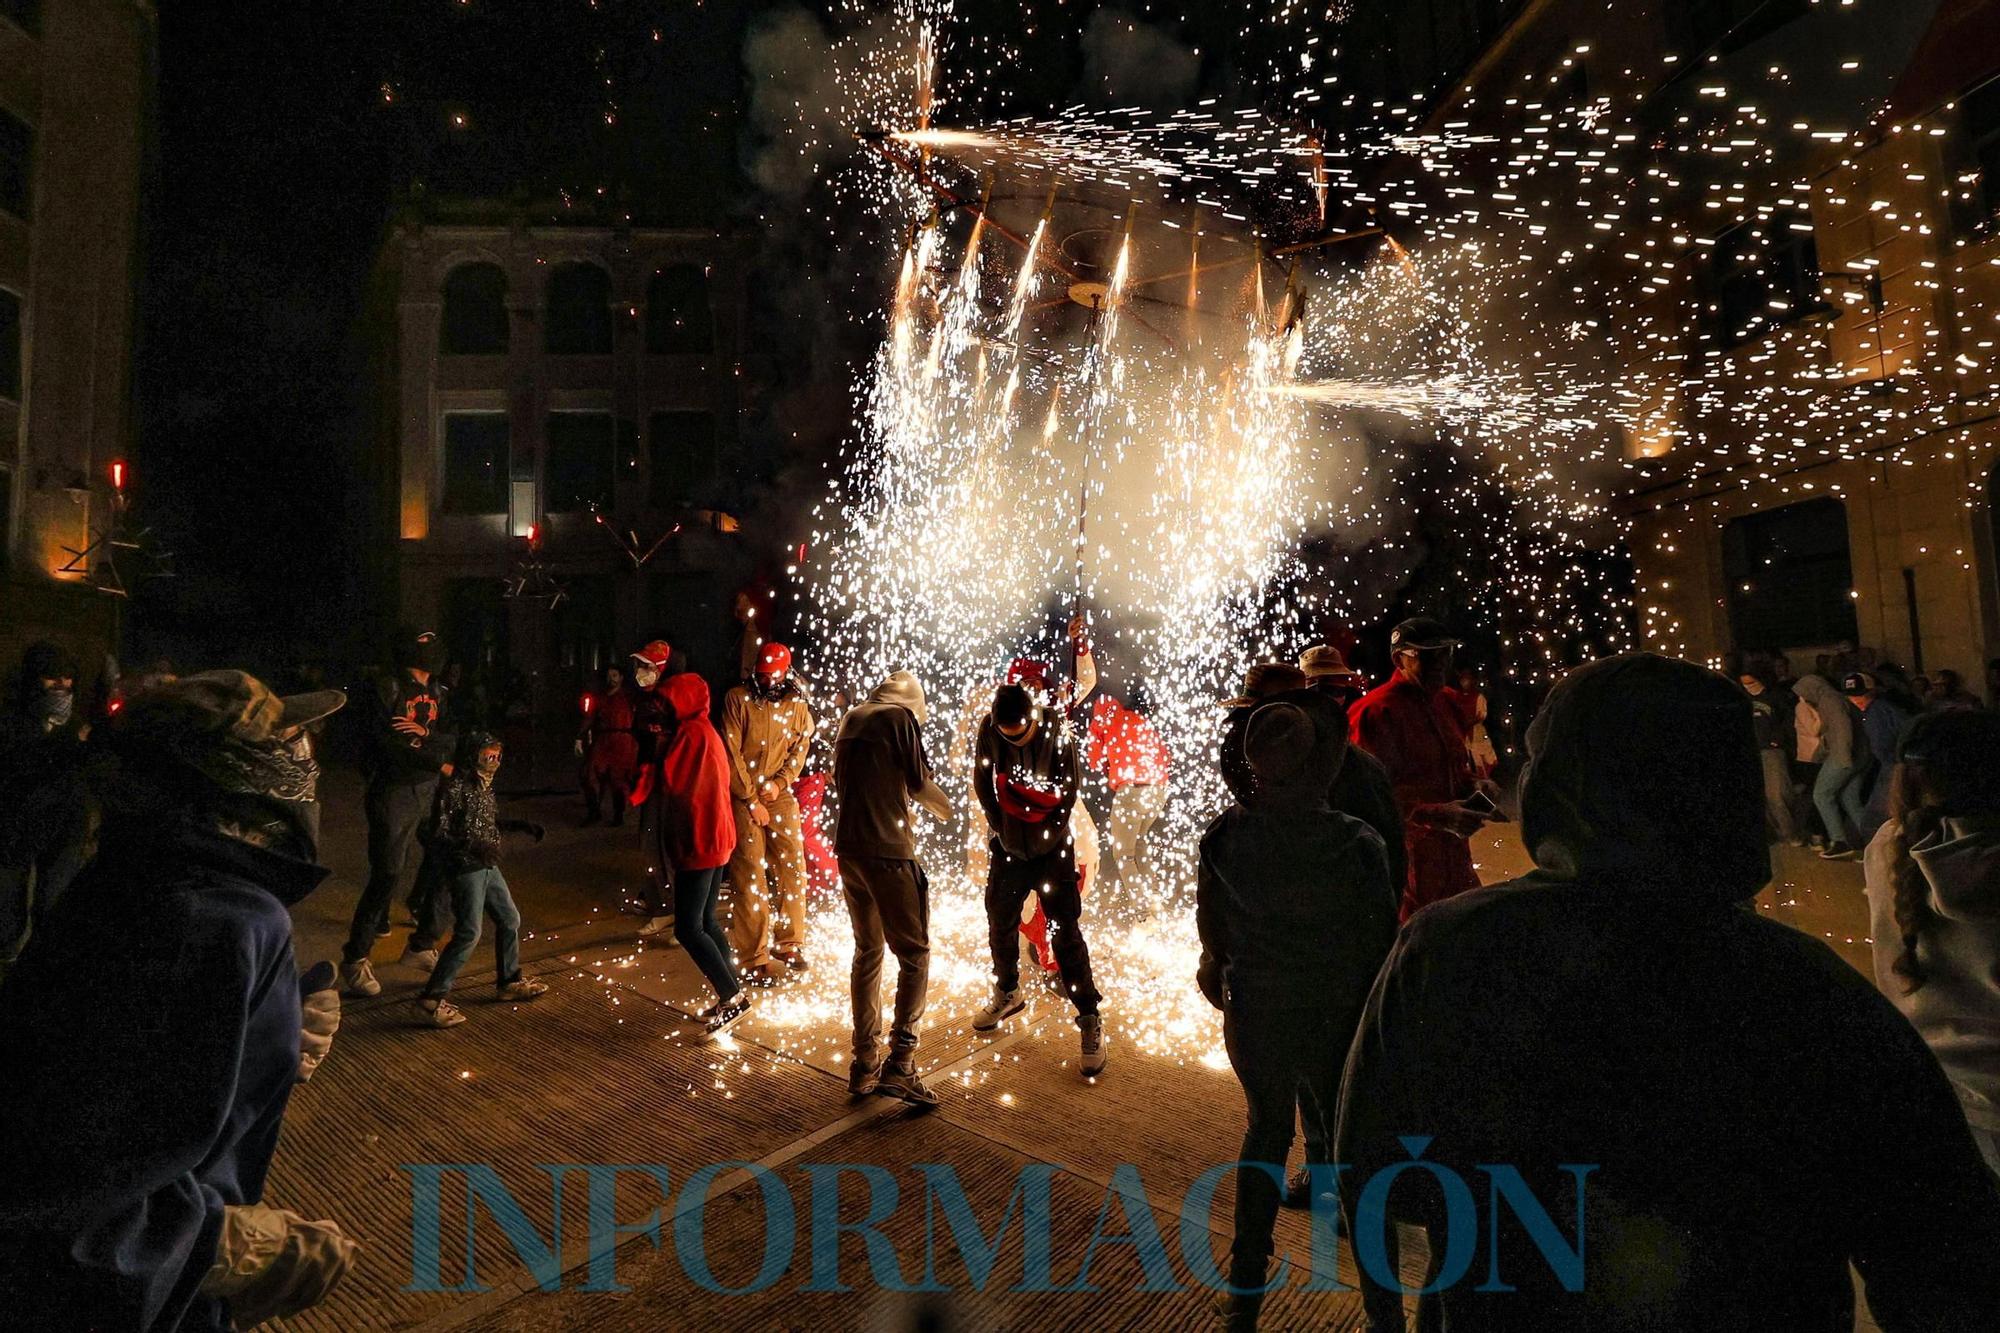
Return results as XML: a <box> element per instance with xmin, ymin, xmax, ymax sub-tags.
<box><xmin>1194</xmin><ymin>695</ymin><xmax>1400</xmax><ymax>1329</ymax></box>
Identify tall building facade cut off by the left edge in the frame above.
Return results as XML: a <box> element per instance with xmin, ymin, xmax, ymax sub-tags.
<box><xmin>0</xmin><ymin>0</ymin><xmax>154</xmax><ymax>658</ymax></box>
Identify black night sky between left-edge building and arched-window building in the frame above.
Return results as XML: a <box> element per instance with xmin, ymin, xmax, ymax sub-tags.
<box><xmin>134</xmin><ymin>0</ymin><xmax>766</xmax><ymax>654</ymax></box>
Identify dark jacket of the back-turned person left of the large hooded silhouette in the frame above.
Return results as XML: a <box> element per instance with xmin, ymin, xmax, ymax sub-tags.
<box><xmin>1194</xmin><ymin>701</ymin><xmax>1398</xmax><ymax>1008</ymax></box>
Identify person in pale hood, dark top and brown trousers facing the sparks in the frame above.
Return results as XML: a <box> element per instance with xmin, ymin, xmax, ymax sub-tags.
<box><xmin>834</xmin><ymin>671</ymin><xmax>952</xmax><ymax>1105</ymax></box>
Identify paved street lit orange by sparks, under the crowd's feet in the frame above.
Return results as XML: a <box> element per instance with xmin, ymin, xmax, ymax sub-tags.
<box><xmin>268</xmin><ymin>775</ymin><xmax>1866</xmax><ymax>1331</ymax></box>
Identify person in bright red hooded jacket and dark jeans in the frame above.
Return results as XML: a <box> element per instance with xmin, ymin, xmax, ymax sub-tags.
<box><xmin>630</xmin><ymin>671</ymin><xmax>750</xmax><ymax>1035</ymax></box>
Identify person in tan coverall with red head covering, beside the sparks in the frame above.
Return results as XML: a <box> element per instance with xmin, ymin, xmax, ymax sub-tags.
<box><xmin>722</xmin><ymin>642</ymin><xmax>812</xmax><ymax>985</ymax></box>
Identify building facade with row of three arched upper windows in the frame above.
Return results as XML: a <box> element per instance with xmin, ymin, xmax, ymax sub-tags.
<box><xmin>370</xmin><ymin>206</ymin><xmax>758</xmax><ymax>717</ymax></box>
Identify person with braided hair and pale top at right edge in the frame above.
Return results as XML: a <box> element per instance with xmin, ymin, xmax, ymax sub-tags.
<box><xmin>1866</xmin><ymin>711</ymin><xmax>2000</xmax><ymax>1175</ymax></box>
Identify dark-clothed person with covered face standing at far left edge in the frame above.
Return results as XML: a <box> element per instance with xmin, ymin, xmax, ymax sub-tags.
<box><xmin>0</xmin><ymin>640</ymin><xmax>92</xmax><ymax>964</ymax></box>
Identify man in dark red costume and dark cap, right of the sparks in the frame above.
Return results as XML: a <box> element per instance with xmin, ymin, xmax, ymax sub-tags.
<box><xmin>1350</xmin><ymin>618</ymin><xmax>1498</xmax><ymax>921</ymax></box>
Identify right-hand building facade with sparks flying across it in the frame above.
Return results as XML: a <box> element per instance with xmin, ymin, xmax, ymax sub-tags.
<box><xmin>1358</xmin><ymin>0</ymin><xmax>2000</xmax><ymax>689</ymax></box>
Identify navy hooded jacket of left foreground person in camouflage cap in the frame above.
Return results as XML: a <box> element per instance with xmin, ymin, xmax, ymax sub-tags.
<box><xmin>0</xmin><ymin>825</ymin><xmax>326</xmax><ymax>1333</ymax></box>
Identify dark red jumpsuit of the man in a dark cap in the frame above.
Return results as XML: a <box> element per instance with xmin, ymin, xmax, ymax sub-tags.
<box><xmin>1348</xmin><ymin>675</ymin><xmax>1480</xmax><ymax>921</ymax></box>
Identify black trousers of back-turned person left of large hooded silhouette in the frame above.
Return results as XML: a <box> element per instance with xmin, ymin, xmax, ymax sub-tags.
<box><xmin>1222</xmin><ymin>997</ymin><xmax>1354</xmax><ymax>1287</ymax></box>
